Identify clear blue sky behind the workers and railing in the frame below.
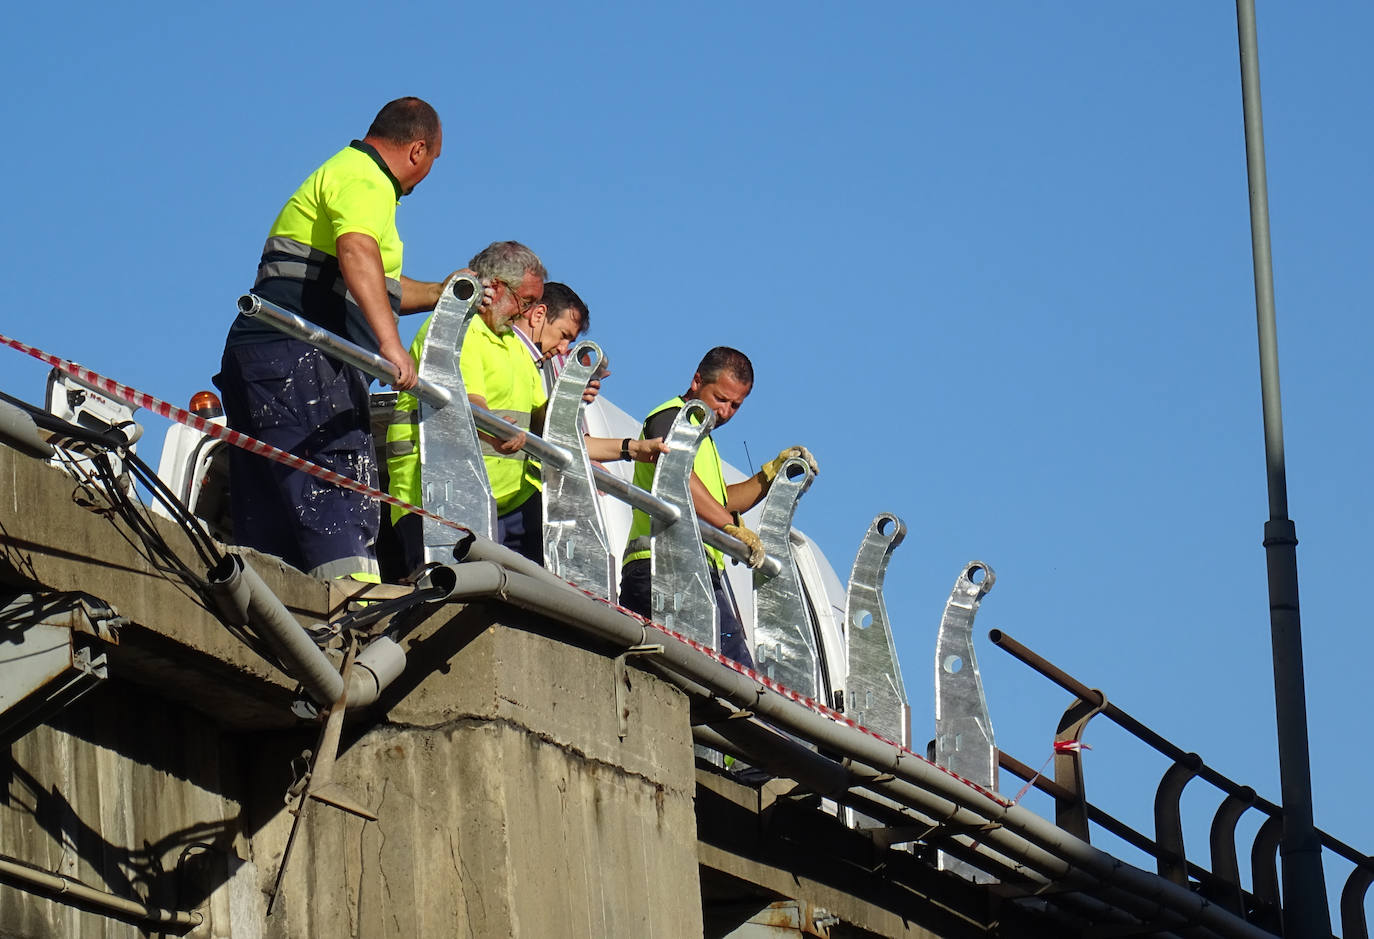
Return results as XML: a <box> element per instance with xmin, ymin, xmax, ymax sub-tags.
<box><xmin>0</xmin><ymin>0</ymin><xmax>1374</xmax><ymax>923</ymax></box>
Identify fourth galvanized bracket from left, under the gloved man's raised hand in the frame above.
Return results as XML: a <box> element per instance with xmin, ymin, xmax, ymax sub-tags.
<box><xmin>753</xmin><ymin>458</ymin><xmax>820</xmax><ymax>698</ymax></box>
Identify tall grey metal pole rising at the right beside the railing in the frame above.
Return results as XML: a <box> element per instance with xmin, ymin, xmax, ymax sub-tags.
<box><xmin>1235</xmin><ymin>0</ymin><xmax>1331</xmax><ymax>939</ymax></box>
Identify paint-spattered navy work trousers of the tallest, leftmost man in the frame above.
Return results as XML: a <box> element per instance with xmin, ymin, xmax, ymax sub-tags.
<box><xmin>214</xmin><ymin>338</ymin><xmax>381</xmax><ymax>577</ymax></box>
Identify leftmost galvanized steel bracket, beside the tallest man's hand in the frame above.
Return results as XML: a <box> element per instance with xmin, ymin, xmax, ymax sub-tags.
<box><xmin>418</xmin><ymin>274</ymin><xmax>496</xmax><ymax>564</ymax></box>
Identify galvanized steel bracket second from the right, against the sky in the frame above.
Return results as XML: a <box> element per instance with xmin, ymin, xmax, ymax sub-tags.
<box><xmin>844</xmin><ymin>513</ymin><xmax>911</xmax><ymax>749</ymax></box>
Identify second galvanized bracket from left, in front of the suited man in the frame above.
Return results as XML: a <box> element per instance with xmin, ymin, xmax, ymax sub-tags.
<box><xmin>543</xmin><ymin>341</ymin><xmax>618</xmax><ymax>602</ymax></box>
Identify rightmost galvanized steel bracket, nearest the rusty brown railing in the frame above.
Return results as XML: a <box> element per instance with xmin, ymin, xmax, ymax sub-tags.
<box><xmin>934</xmin><ymin>561</ymin><xmax>998</xmax><ymax>883</ymax></box>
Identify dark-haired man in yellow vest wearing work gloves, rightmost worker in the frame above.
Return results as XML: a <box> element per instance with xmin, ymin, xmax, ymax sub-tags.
<box><xmin>620</xmin><ymin>345</ymin><xmax>819</xmax><ymax>665</ymax></box>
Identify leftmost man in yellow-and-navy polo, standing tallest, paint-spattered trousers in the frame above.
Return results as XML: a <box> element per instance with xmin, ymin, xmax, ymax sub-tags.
<box><xmin>214</xmin><ymin>98</ymin><xmax>453</xmax><ymax>580</ymax></box>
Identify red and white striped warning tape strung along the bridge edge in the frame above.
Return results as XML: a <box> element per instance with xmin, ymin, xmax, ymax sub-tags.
<box><xmin>0</xmin><ymin>333</ymin><xmax>1005</xmax><ymax>806</ymax></box>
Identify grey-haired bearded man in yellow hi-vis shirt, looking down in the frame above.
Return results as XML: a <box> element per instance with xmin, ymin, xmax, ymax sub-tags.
<box><xmin>386</xmin><ymin>241</ymin><xmax>665</xmax><ymax>571</ymax></box>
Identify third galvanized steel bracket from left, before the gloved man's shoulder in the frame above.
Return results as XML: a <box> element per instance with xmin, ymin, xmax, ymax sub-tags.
<box><xmin>650</xmin><ymin>399</ymin><xmax>720</xmax><ymax>649</ymax></box>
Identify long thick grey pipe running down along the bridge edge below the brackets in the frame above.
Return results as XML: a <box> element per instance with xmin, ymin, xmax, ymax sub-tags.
<box><xmin>439</xmin><ymin>571</ymin><xmax>1272</xmax><ymax>939</ymax></box>
